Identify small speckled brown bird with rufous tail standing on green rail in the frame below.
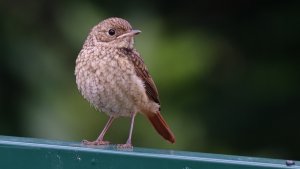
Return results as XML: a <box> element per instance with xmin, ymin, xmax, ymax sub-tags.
<box><xmin>75</xmin><ymin>17</ymin><xmax>175</xmax><ymax>148</ymax></box>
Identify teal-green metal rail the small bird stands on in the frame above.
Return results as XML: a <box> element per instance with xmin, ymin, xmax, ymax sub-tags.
<box><xmin>0</xmin><ymin>136</ymin><xmax>300</xmax><ymax>169</ymax></box>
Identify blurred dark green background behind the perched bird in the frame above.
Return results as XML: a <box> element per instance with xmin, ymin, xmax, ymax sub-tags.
<box><xmin>0</xmin><ymin>0</ymin><xmax>300</xmax><ymax>160</ymax></box>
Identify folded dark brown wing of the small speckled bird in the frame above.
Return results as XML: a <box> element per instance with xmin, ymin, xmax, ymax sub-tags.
<box><xmin>129</xmin><ymin>50</ymin><xmax>160</xmax><ymax>104</ymax></box>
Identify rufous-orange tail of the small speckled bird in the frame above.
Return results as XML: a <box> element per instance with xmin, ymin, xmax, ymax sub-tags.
<box><xmin>146</xmin><ymin>112</ymin><xmax>175</xmax><ymax>143</ymax></box>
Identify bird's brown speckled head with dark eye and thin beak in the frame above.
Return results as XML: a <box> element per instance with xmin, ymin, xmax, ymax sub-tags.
<box><xmin>89</xmin><ymin>18</ymin><xmax>141</xmax><ymax>48</ymax></box>
